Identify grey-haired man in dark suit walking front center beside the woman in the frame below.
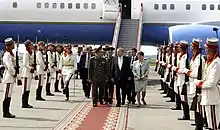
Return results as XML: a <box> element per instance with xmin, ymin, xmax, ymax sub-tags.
<box><xmin>112</xmin><ymin>48</ymin><xmax>131</xmax><ymax>107</ymax></box>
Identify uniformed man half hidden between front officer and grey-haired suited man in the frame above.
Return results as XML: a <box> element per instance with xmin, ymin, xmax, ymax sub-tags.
<box><xmin>104</xmin><ymin>47</ymin><xmax>115</xmax><ymax>104</ymax></box>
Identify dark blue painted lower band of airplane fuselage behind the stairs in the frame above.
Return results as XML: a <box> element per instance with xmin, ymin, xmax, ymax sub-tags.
<box><xmin>0</xmin><ymin>23</ymin><xmax>168</xmax><ymax>44</ymax></box>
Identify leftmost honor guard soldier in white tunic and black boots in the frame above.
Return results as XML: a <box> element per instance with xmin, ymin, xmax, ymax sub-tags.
<box><xmin>3</xmin><ymin>38</ymin><xmax>17</xmax><ymax>118</ymax></box>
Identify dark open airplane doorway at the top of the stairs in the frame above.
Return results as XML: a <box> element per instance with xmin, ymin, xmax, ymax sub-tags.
<box><xmin>119</xmin><ymin>0</ymin><xmax>131</xmax><ymax>19</ymax></box>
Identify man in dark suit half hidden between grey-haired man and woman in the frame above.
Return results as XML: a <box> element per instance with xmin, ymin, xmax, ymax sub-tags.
<box><xmin>128</xmin><ymin>48</ymin><xmax>138</xmax><ymax>104</ymax></box>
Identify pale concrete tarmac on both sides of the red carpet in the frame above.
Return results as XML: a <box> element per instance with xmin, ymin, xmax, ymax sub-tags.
<box><xmin>0</xmin><ymin>67</ymin><xmax>198</xmax><ymax>130</ymax></box>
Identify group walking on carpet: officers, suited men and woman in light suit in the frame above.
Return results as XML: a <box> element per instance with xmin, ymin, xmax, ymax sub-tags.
<box><xmin>88</xmin><ymin>46</ymin><xmax>149</xmax><ymax>107</ymax></box>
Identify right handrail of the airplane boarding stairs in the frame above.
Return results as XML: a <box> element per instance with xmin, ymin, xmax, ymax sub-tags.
<box><xmin>136</xmin><ymin>3</ymin><xmax>143</xmax><ymax>51</ymax></box>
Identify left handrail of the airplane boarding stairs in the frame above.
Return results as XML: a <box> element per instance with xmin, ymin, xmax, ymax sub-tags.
<box><xmin>112</xmin><ymin>3</ymin><xmax>122</xmax><ymax>55</ymax></box>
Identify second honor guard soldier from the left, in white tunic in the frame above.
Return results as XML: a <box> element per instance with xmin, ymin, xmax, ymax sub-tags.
<box><xmin>22</xmin><ymin>40</ymin><xmax>35</xmax><ymax>108</ymax></box>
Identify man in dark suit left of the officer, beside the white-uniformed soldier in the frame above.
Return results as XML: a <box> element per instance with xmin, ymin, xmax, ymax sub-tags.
<box><xmin>79</xmin><ymin>47</ymin><xmax>92</xmax><ymax>98</ymax></box>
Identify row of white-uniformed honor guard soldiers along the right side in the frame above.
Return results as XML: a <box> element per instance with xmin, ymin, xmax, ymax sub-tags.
<box><xmin>155</xmin><ymin>37</ymin><xmax>220</xmax><ymax>130</ymax></box>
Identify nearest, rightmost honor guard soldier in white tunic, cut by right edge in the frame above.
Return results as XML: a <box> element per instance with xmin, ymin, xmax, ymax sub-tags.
<box><xmin>196</xmin><ymin>38</ymin><xmax>220</xmax><ymax>130</ymax></box>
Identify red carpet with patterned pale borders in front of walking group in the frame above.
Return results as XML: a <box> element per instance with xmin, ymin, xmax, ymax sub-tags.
<box><xmin>64</xmin><ymin>102</ymin><xmax>128</xmax><ymax>130</ymax></box>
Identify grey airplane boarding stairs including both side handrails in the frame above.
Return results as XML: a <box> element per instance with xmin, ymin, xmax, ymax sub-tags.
<box><xmin>112</xmin><ymin>4</ymin><xmax>143</xmax><ymax>52</ymax></box>
